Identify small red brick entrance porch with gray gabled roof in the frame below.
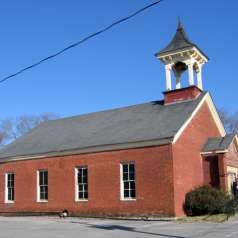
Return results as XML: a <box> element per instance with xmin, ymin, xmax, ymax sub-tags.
<box><xmin>201</xmin><ymin>134</ymin><xmax>238</xmax><ymax>194</ymax></box>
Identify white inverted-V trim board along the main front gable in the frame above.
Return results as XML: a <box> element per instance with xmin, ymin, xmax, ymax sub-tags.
<box><xmin>172</xmin><ymin>93</ymin><xmax>226</xmax><ymax>144</ymax></box>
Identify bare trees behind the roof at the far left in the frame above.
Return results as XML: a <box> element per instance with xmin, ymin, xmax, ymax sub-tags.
<box><xmin>0</xmin><ymin>113</ymin><xmax>58</xmax><ymax>146</ymax></box>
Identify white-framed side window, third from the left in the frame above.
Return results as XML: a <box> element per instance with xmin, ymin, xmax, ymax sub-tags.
<box><xmin>75</xmin><ymin>167</ymin><xmax>88</xmax><ymax>201</ymax></box>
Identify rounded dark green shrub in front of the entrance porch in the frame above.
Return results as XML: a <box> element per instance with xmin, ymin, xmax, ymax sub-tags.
<box><xmin>184</xmin><ymin>186</ymin><xmax>230</xmax><ymax>216</ymax></box>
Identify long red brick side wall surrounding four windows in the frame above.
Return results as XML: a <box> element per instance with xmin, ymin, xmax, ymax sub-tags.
<box><xmin>0</xmin><ymin>145</ymin><xmax>174</xmax><ymax>216</ymax></box>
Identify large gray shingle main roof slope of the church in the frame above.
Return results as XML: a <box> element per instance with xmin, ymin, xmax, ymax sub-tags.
<box><xmin>0</xmin><ymin>93</ymin><xmax>205</xmax><ymax>159</ymax></box>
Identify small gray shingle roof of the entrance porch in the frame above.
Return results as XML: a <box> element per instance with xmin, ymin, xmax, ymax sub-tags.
<box><xmin>202</xmin><ymin>134</ymin><xmax>235</xmax><ymax>152</ymax></box>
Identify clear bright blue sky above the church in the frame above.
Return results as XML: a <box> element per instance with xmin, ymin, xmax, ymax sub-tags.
<box><xmin>0</xmin><ymin>0</ymin><xmax>238</xmax><ymax>119</ymax></box>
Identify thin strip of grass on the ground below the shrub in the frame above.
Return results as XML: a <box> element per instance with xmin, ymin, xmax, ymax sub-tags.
<box><xmin>177</xmin><ymin>214</ymin><xmax>229</xmax><ymax>223</ymax></box>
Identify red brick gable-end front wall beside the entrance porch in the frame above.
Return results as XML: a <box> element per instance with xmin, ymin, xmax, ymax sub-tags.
<box><xmin>173</xmin><ymin>103</ymin><xmax>220</xmax><ymax>216</ymax></box>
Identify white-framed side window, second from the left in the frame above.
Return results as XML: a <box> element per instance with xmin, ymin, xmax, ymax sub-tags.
<box><xmin>37</xmin><ymin>170</ymin><xmax>48</xmax><ymax>202</ymax></box>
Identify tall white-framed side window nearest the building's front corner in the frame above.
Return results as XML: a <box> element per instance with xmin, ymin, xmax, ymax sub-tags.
<box><xmin>121</xmin><ymin>163</ymin><xmax>136</xmax><ymax>200</ymax></box>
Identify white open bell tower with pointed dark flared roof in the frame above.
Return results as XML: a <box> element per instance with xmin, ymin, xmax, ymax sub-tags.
<box><xmin>155</xmin><ymin>21</ymin><xmax>209</xmax><ymax>91</ymax></box>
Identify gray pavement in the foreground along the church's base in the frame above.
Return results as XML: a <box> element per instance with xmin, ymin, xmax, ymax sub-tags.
<box><xmin>0</xmin><ymin>217</ymin><xmax>238</xmax><ymax>238</ymax></box>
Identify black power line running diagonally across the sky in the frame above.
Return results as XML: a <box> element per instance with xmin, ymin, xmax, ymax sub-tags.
<box><xmin>0</xmin><ymin>0</ymin><xmax>163</xmax><ymax>83</ymax></box>
